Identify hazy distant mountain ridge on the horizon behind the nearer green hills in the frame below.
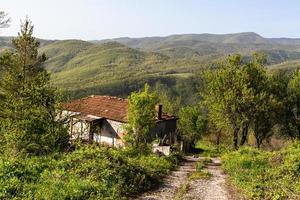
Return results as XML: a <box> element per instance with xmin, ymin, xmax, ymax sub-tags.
<box><xmin>92</xmin><ymin>32</ymin><xmax>300</xmax><ymax>59</ymax></box>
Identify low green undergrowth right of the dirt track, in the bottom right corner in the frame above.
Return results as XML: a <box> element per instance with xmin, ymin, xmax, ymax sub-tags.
<box><xmin>222</xmin><ymin>142</ymin><xmax>300</xmax><ymax>200</ymax></box>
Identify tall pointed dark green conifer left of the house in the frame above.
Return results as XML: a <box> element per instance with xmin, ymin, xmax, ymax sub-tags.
<box><xmin>0</xmin><ymin>19</ymin><xmax>68</xmax><ymax>154</ymax></box>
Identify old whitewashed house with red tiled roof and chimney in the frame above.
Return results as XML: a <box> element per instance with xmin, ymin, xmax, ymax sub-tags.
<box><xmin>61</xmin><ymin>96</ymin><xmax>177</xmax><ymax>147</ymax></box>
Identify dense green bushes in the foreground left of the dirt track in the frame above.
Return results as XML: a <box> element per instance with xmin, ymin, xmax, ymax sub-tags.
<box><xmin>0</xmin><ymin>145</ymin><xmax>177</xmax><ymax>199</ymax></box>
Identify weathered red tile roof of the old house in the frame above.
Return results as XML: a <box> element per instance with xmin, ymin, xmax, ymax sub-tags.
<box><xmin>63</xmin><ymin>95</ymin><xmax>177</xmax><ymax>122</ymax></box>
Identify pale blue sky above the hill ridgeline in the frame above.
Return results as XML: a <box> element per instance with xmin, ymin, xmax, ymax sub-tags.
<box><xmin>0</xmin><ymin>0</ymin><xmax>300</xmax><ymax>40</ymax></box>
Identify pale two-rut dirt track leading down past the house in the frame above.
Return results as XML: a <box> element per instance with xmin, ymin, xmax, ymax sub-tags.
<box><xmin>136</xmin><ymin>156</ymin><xmax>237</xmax><ymax>200</ymax></box>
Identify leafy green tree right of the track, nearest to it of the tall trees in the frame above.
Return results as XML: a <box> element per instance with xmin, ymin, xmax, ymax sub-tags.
<box><xmin>202</xmin><ymin>55</ymin><xmax>250</xmax><ymax>148</ymax></box>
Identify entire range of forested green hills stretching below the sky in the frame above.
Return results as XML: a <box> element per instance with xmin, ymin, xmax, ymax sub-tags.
<box><xmin>0</xmin><ymin>32</ymin><xmax>300</xmax><ymax>100</ymax></box>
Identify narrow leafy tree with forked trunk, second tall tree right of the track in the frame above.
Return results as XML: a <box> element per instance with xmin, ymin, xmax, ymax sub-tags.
<box><xmin>240</xmin><ymin>54</ymin><xmax>276</xmax><ymax>147</ymax></box>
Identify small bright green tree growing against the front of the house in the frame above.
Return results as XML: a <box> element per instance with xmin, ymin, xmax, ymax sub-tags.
<box><xmin>125</xmin><ymin>84</ymin><xmax>158</xmax><ymax>146</ymax></box>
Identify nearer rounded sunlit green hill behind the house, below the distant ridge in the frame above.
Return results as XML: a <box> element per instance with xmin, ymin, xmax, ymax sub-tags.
<box><xmin>40</xmin><ymin>40</ymin><xmax>202</xmax><ymax>96</ymax></box>
